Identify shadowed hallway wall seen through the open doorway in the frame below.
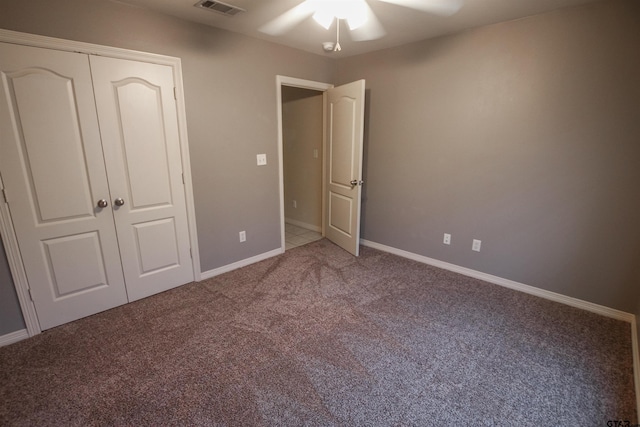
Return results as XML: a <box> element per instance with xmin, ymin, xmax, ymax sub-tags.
<box><xmin>282</xmin><ymin>86</ymin><xmax>323</xmax><ymax>231</ymax></box>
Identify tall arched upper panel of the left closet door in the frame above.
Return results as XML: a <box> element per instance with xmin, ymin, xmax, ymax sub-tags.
<box><xmin>7</xmin><ymin>69</ymin><xmax>93</xmax><ymax>223</ymax></box>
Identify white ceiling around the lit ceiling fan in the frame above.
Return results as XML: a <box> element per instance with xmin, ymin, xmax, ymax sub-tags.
<box><xmin>114</xmin><ymin>0</ymin><xmax>598</xmax><ymax>57</ymax></box>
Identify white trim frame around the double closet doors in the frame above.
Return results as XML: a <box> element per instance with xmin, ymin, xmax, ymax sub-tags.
<box><xmin>0</xmin><ymin>29</ymin><xmax>202</xmax><ymax>337</ymax></box>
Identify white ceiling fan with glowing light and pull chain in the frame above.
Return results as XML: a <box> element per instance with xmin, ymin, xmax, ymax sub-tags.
<box><xmin>259</xmin><ymin>0</ymin><xmax>464</xmax><ymax>51</ymax></box>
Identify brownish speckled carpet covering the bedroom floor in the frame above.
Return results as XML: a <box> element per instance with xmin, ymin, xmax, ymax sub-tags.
<box><xmin>0</xmin><ymin>240</ymin><xmax>637</xmax><ymax>426</ymax></box>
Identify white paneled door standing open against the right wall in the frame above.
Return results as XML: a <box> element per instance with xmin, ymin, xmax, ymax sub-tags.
<box><xmin>324</xmin><ymin>80</ymin><xmax>365</xmax><ymax>256</ymax></box>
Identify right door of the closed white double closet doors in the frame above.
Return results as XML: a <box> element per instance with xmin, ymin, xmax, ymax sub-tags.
<box><xmin>90</xmin><ymin>56</ymin><xmax>193</xmax><ymax>301</ymax></box>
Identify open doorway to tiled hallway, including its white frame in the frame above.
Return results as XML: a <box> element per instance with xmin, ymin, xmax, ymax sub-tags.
<box><xmin>277</xmin><ymin>76</ymin><xmax>333</xmax><ymax>251</ymax></box>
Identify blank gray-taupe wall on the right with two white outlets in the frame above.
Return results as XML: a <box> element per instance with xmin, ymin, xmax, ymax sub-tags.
<box><xmin>336</xmin><ymin>0</ymin><xmax>640</xmax><ymax>313</ymax></box>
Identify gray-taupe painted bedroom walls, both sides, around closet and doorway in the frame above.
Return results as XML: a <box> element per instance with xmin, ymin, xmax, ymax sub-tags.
<box><xmin>0</xmin><ymin>0</ymin><xmax>640</xmax><ymax>333</ymax></box>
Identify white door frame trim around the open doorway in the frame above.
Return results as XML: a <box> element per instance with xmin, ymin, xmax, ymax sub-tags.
<box><xmin>276</xmin><ymin>75</ymin><xmax>334</xmax><ymax>253</ymax></box>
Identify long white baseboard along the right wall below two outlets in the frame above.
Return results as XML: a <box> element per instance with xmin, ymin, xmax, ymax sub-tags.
<box><xmin>360</xmin><ymin>239</ymin><xmax>635</xmax><ymax>323</ymax></box>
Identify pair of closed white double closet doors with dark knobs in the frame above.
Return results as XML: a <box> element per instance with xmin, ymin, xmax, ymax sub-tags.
<box><xmin>0</xmin><ymin>43</ymin><xmax>193</xmax><ymax>329</ymax></box>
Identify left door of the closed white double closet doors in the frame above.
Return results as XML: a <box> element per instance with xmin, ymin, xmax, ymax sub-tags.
<box><xmin>0</xmin><ymin>43</ymin><xmax>127</xmax><ymax>329</ymax></box>
